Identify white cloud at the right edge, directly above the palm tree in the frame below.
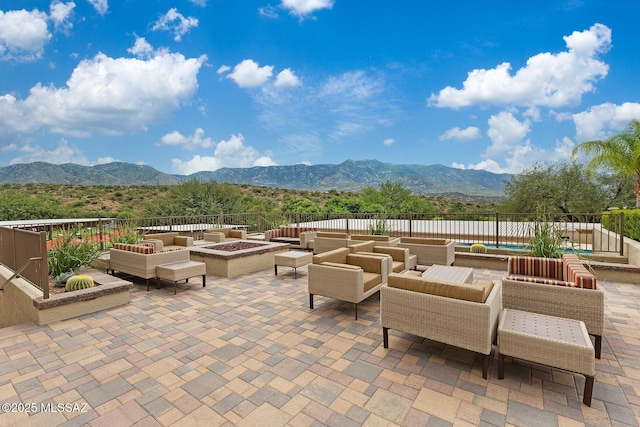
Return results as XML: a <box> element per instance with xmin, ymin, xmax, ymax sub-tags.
<box><xmin>573</xmin><ymin>102</ymin><xmax>640</xmax><ymax>142</ymax></box>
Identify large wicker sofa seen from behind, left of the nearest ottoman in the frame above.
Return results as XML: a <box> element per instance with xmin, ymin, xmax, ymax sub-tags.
<box><xmin>380</xmin><ymin>273</ymin><xmax>500</xmax><ymax>379</ymax></box>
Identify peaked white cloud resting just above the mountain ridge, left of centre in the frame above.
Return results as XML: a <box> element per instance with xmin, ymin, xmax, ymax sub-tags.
<box><xmin>171</xmin><ymin>134</ymin><xmax>275</xmax><ymax>175</ymax></box>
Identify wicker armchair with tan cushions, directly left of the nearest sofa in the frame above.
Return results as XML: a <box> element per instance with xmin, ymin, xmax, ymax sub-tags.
<box><xmin>308</xmin><ymin>248</ymin><xmax>388</xmax><ymax>320</ymax></box>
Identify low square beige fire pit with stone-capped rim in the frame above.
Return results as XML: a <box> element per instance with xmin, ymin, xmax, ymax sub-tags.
<box><xmin>189</xmin><ymin>240</ymin><xmax>291</xmax><ymax>277</ymax></box>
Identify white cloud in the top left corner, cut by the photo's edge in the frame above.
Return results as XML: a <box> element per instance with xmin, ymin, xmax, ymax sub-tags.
<box><xmin>0</xmin><ymin>9</ymin><xmax>51</xmax><ymax>62</ymax></box>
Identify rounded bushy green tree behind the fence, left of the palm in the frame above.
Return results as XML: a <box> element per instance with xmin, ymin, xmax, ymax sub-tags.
<box><xmin>502</xmin><ymin>162</ymin><xmax>607</xmax><ymax>214</ymax></box>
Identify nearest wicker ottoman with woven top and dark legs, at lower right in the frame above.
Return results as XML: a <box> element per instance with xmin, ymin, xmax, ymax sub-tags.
<box><xmin>498</xmin><ymin>308</ymin><xmax>596</xmax><ymax>406</ymax></box>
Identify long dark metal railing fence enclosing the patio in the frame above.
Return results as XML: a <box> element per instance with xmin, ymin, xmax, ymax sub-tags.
<box><xmin>0</xmin><ymin>212</ymin><xmax>624</xmax><ymax>298</ymax></box>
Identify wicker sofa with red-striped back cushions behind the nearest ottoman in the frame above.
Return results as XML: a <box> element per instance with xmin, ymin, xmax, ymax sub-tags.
<box><xmin>502</xmin><ymin>253</ymin><xmax>604</xmax><ymax>359</ymax></box>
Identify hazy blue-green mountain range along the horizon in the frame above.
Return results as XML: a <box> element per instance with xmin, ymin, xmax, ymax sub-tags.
<box><xmin>0</xmin><ymin>160</ymin><xmax>511</xmax><ymax>198</ymax></box>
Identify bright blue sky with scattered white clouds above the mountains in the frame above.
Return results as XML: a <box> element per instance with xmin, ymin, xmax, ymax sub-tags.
<box><xmin>0</xmin><ymin>0</ymin><xmax>640</xmax><ymax>174</ymax></box>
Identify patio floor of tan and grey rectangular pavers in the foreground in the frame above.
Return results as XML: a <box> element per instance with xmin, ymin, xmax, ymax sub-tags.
<box><xmin>0</xmin><ymin>266</ymin><xmax>640</xmax><ymax>427</ymax></box>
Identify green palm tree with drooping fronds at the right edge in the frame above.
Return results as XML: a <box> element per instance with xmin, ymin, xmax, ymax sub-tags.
<box><xmin>572</xmin><ymin>120</ymin><xmax>640</xmax><ymax>208</ymax></box>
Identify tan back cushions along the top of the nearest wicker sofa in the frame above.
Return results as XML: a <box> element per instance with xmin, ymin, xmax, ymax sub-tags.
<box><xmin>388</xmin><ymin>273</ymin><xmax>493</xmax><ymax>303</ymax></box>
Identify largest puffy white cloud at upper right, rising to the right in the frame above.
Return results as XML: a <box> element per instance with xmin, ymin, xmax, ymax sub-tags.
<box><xmin>428</xmin><ymin>24</ymin><xmax>611</xmax><ymax>109</ymax></box>
